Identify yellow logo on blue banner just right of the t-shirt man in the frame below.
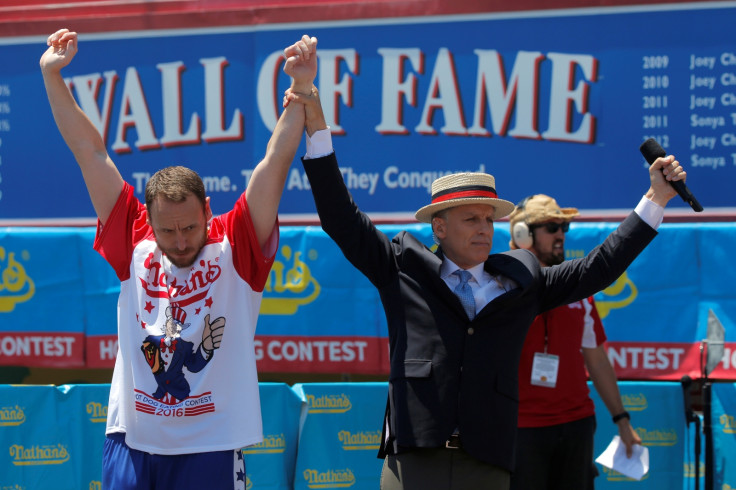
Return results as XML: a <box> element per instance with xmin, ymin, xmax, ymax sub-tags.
<box><xmin>261</xmin><ymin>245</ymin><xmax>320</xmax><ymax>315</ymax></box>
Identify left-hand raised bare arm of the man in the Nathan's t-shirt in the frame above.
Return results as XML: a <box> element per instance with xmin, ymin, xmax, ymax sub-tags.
<box><xmin>39</xmin><ymin>29</ymin><xmax>123</xmax><ymax>224</ymax></box>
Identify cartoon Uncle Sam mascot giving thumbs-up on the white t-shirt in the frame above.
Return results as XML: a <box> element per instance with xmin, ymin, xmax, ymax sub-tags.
<box><xmin>141</xmin><ymin>303</ymin><xmax>225</xmax><ymax>404</ymax></box>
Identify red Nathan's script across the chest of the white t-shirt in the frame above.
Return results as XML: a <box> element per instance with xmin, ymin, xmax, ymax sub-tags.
<box><xmin>138</xmin><ymin>253</ymin><xmax>222</xmax><ymax>307</ymax></box>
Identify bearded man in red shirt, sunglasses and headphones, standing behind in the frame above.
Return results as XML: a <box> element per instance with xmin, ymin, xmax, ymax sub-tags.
<box><xmin>509</xmin><ymin>194</ymin><xmax>641</xmax><ymax>490</ymax></box>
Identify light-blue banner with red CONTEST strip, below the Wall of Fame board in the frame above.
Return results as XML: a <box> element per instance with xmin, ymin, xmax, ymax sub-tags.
<box><xmin>0</xmin><ymin>221</ymin><xmax>736</xmax><ymax>380</ymax></box>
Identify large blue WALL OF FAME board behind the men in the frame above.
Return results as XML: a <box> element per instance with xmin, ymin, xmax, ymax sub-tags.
<box><xmin>0</xmin><ymin>2</ymin><xmax>736</xmax><ymax>224</ymax></box>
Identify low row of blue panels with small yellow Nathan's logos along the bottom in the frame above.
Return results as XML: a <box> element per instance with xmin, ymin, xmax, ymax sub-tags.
<box><xmin>0</xmin><ymin>381</ymin><xmax>736</xmax><ymax>490</ymax></box>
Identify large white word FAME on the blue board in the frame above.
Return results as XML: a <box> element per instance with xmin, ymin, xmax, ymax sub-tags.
<box><xmin>376</xmin><ymin>48</ymin><xmax>598</xmax><ymax>143</ymax></box>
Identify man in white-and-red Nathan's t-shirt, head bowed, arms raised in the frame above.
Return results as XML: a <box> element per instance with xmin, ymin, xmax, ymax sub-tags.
<box><xmin>40</xmin><ymin>29</ymin><xmax>317</xmax><ymax>490</ymax></box>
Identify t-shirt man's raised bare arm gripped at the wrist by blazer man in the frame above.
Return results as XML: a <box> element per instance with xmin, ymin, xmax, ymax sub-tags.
<box><xmin>245</xmin><ymin>36</ymin><xmax>317</xmax><ymax>247</ymax></box>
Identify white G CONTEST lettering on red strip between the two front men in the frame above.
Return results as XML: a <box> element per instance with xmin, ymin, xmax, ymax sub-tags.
<box><xmin>255</xmin><ymin>340</ymin><xmax>368</xmax><ymax>362</ymax></box>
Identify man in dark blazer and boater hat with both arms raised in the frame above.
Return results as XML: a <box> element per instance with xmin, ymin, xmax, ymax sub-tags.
<box><xmin>285</xmin><ymin>88</ymin><xmax>685</xmax><ymax>490</ymax></box>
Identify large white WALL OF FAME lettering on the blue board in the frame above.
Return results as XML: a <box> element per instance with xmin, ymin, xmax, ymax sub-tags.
<box><xmin>66</xmin><ymin>47</ymin><xmax>600</xmax><ymax>149</ymax></box>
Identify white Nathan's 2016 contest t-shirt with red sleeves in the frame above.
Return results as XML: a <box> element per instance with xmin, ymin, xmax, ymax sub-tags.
<box><xmin>94</xmin><ymin>183</ymin><xmax>278</xmax><ymax>454</ymax></box>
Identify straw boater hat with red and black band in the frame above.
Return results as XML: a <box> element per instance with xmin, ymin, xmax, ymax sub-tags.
<box><xmin>415</xmin><ymin>173</ymin><xmax>514</xmax><ymax>223</ymax></box>
